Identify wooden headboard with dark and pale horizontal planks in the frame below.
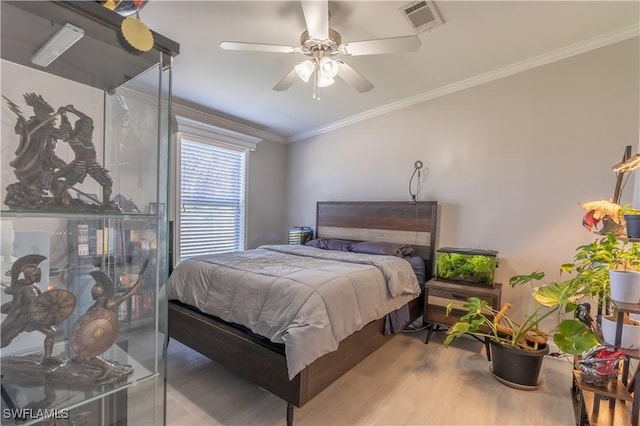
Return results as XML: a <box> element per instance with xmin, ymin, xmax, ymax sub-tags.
<box><xmin>316</xmin><ymin>201</ymin><xmax>438</xmax><ymax>279</ymax></box>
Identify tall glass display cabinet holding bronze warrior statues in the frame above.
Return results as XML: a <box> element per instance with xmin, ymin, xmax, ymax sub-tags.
<box><xmin>0</xmin><ymin>1</ymin><xmax>179</xmax><ymax>425</ymax></box>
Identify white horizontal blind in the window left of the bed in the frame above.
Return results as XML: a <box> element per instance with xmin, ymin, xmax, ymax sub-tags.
<box><xmin>179</xmin><ymin>137</ymin><xmax>246</xmax><ymax>260</ymax></box>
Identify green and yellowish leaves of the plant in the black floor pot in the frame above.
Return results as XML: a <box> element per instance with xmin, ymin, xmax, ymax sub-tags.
<box><xmin>444</xmin><ymin>272</ymin><xmax>598</xmax><ymax>354</ymax></box>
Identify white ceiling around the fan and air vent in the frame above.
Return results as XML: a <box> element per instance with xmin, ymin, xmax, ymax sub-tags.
<box><xmin>140</xmin><ymin>0</ymin><xmax>640</xmax><ymax>142</ymax></box>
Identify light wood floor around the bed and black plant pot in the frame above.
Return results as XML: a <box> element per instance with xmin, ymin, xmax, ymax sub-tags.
<box><xmin>166</xmin><ymin>331</ymin><xmax>575</xmax><ymax>426</ymax></box>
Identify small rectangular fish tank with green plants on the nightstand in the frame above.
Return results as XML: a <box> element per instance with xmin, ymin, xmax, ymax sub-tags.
<box><xmin>436</xmin><ymin>247</ymin><xmax>498</xmax><ymax>287</ymax></box>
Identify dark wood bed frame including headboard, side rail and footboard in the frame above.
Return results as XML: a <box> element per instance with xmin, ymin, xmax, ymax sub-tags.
<box><xmin>169</xmin><ymin>201</ymin><xmax>437</xmax><ymax>425</ymax></box>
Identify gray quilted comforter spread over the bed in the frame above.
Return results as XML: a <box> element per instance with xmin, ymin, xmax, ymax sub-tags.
<box><xmin>168</xmin><ymin>245</ymin><xmax>420</xmax><ymax>379</ymax></box>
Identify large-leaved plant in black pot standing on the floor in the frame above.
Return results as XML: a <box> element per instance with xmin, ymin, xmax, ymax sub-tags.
<box><xmin>444</xmin><ymin>272</ymin><xmax>599</xmax><ymax>389</ymax></box>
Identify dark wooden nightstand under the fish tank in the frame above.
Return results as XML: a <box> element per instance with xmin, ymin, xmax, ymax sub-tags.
<box><xmin>423</xmin><ymin>278</ymin><xmax>502</xmax><ymax>359</ymax></box>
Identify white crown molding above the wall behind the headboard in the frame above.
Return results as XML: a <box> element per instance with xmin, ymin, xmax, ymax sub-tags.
<box><xmin>286</xmin><ymin>24</ymin><xmax>640</xmax><ymax>143</ymax></box>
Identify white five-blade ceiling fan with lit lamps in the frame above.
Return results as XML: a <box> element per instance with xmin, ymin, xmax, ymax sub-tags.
<box><xmin>220</xmin><ymin>0</ymin><xmax>421</xmax><ymax>98</ymax></box>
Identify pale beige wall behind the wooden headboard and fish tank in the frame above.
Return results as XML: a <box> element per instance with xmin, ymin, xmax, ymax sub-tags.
<box><xmin>286</xmin><ymin>38</ymin><xmax>639</xmax><ymax>318</ymax></box>
